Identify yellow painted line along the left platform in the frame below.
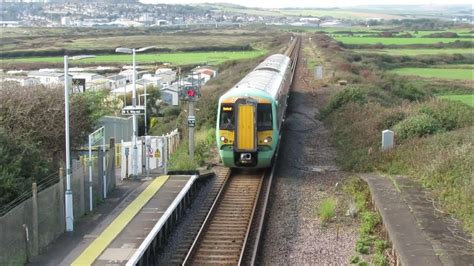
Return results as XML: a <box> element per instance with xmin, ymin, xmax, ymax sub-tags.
<box><xmin>71</xmin><ymin>176</ymin><xmax>169</xmax><ymax>266</ymax></box>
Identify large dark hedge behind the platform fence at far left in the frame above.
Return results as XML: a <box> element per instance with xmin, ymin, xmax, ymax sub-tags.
<box><xmin>0</xmin><ymin>83</ymin><xmax>115</xmax><ymax>205</ymax></box>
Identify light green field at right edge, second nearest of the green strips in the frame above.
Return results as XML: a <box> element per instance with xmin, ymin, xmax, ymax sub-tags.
<box><xmin>390</xmin><ymin>68</ymin><xmax>474</xmax><ymax>80</ymax></box>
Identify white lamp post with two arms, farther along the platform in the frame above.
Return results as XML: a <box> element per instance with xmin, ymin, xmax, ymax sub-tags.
<box><xmin>115</xmin><ymin>46</ymin><xmax>158</xmax><ymax>178</ymax></box>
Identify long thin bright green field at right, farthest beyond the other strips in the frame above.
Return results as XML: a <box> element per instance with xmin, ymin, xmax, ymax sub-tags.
<box><xmin>334</xmin><ymin>36</ymin><xmax>474</xmax><ymax>45</ymax></box>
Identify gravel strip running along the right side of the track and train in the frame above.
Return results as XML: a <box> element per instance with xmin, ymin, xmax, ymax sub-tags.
<box><xmin>259</xmin><ymin>38</ymin><xmax>358</xmax><ymax>265</ymax></box>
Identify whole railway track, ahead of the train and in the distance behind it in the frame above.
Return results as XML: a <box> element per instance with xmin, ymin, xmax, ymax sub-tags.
<box><xmin>171</xmin><ymin>38</ymin><xmax>300</xmax><ymax>265</ymax></box>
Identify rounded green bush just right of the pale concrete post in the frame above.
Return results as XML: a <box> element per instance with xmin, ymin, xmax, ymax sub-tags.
<box><xmin>394</xmin><ymin>113</ymin><xmax>442</xmax><ymax>140</ymax></box>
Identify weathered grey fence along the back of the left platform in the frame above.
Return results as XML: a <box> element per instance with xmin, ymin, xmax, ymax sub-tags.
<box><xmin>0</xmin><ymin>139</ymin><xmax>115</xmax><ymax>265</ymax></box>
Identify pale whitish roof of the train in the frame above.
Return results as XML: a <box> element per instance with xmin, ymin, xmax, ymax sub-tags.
<box><xmin>222</xmin><ymin>54</ymin><xmax>290</xmax><ymax>99</ymax></box>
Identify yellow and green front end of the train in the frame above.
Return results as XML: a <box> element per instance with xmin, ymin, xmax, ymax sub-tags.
<box><xmin>216</xmin><ymin>94</ymin><xmax>278</xmax><ymax>168</ymax></box>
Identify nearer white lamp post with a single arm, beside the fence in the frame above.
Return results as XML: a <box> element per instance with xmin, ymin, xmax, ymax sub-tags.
<box><xmin>64</xmin><ymin>55</ymin><xmax>95</xmax><ymax>232</ymax></box>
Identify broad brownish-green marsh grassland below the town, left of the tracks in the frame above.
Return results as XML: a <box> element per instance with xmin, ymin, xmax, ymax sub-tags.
<box><xmin>0</xmin><ymin>28</ymin><xmax>273</xmax><ymax>53</ymax></box>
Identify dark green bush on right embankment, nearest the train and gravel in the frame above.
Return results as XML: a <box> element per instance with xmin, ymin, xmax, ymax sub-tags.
<box><xmin>321</xmin><ymin>87</ymin><xmax>367</xmax><ymax>118</ymax></box>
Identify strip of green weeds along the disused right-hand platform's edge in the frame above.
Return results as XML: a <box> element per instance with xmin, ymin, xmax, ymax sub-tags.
<box><xmin>343</xmin><ymin>177</ymin><xmax>389</xmax><ymax>265</ymax></box>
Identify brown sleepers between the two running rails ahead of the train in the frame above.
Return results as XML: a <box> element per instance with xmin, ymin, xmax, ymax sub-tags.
<box><xmin>183</xmin><ymin>171</ymin><xmax>265</xmax><ymax>265</ymax></box>
